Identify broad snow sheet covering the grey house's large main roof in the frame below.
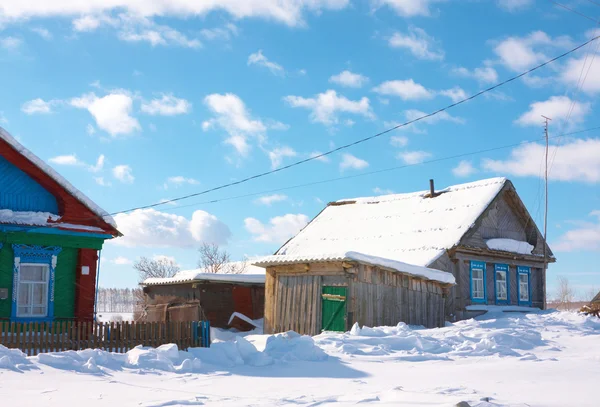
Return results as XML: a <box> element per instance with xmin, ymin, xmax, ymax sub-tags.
<box><xmin>276</xmin><ymin>178</ymin><xmax>506</xmax><ymax>266</ymax></box>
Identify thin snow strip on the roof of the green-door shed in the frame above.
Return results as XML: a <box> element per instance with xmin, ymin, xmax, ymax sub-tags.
<box><xmin>253</xmin><ymin>252</ymin><xmax>455</xmax><ymax>284</ymax></box>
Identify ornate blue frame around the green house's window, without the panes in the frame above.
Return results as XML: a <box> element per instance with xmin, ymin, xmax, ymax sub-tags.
<box><xmin>11</xmin><ymin>244</ymin><xmax>62</xmax><ymax>322</ymax></box>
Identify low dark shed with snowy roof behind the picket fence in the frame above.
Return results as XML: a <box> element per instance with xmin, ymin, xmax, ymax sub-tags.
<box><xmin>142</xmin><ymin>262</ymin><xmax>265</xmax><ymax>328</ymax></box>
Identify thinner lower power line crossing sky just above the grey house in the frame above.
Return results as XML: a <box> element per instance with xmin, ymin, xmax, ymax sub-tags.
<box><xmin>157</xmin><ymin>126</ymin><xmax>600</xmax><ymax>212</ymax></box>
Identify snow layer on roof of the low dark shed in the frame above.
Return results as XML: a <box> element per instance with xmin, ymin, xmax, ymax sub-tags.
<box><xmin>142</xmin><ymin>261</ymin><xmax>265</xmax><ymax>285</ymax></box>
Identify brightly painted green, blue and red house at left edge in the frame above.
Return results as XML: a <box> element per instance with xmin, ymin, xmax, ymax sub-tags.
<box><xmin>0</xmin><ymin>128</ymin><xmax>120</xmax><ymax>322</ymax></box>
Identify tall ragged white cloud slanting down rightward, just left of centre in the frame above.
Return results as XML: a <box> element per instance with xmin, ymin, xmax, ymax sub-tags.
<box><xmin>202</xmin><ymin>93</ymin><xmax>267</xmax><ymax>156</ymax></box>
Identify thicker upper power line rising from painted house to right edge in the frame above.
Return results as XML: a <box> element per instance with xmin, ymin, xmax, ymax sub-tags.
<box><xmin>105</xmin><ymin>36</ymin><xmax>600</xmax><ymax>215</ymax></box>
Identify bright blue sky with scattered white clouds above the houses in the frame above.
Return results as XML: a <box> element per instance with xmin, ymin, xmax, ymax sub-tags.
<box><xmin>0</xmin><ymin>0</ymin><xmax>600</xmax><ymax>296</ymax></box>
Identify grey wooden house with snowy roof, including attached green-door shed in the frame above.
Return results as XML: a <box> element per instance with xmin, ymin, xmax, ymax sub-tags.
<box><xmin>254</xmin><ymin>178</ymin><xmax>555</xmax><ymax>334</ymax></box>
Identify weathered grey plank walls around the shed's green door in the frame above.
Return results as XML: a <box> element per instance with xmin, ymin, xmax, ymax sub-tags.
<box><xmin>265</xmin><ymin>264</ymin><xmax>445</xmax><ymax>335</ymax></box>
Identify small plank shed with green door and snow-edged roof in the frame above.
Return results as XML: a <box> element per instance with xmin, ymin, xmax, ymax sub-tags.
<box><xmin>254</xmin><ymin>252</ymin><xmax>454</xmax><ymax>335</ymax></box>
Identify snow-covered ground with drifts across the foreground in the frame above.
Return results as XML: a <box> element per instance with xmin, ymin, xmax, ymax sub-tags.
<box><xmin>0</xmin><ymin>312</ymin><xmax>600</xmax><ymax>407</ymax></box>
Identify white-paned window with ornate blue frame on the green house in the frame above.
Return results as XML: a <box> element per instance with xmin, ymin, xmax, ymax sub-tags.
<box><xmin>11</xmin><ymin>244</ymin><xmax>62</xmax><ymax>321</ymax></box>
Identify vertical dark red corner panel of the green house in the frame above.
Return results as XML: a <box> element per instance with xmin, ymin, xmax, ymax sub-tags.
<box><xmin>75</xmin><ymin>249</ymin><xmax>98</xmax><ymax>321</ymax></box>
